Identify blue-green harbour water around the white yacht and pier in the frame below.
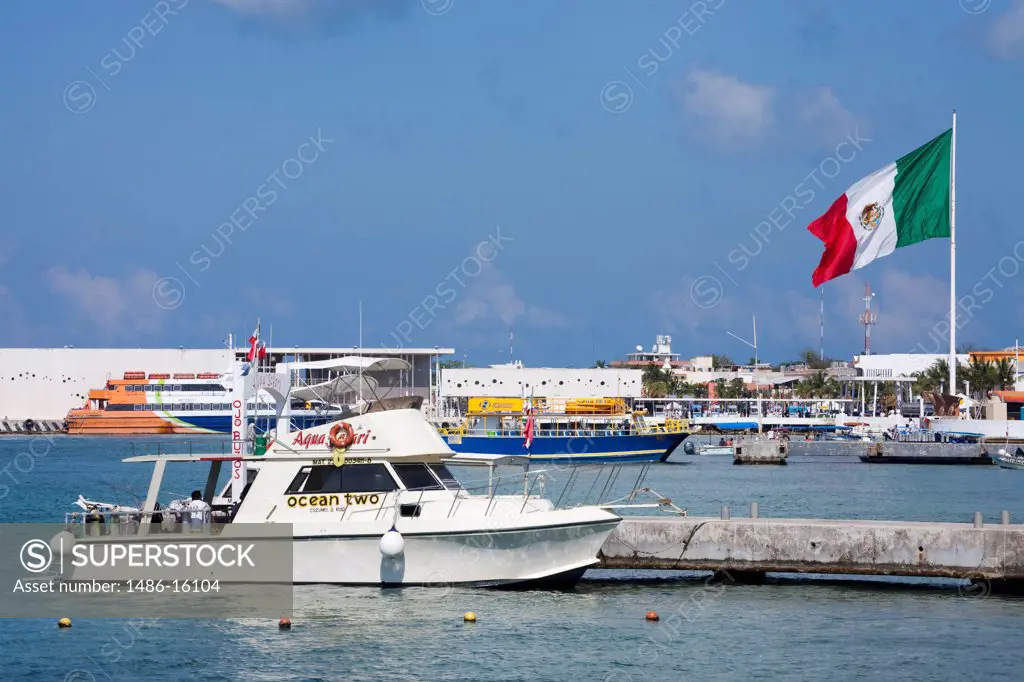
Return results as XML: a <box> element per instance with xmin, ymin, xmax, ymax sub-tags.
<box><xmin>0</xmin><ymin>437</ymin><xmax>1024</xmax><ymax>682</ymax></box>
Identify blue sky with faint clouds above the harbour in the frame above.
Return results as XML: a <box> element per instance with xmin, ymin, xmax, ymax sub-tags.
<box><xmin>0</xmin><ymin>0</ymin><xmax>1024</xmax><ymax>366</ymax></box>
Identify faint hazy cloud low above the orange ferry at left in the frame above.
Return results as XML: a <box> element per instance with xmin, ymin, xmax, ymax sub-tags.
<box><xmin>46</xmin><ymin>265</ymin><xmax>165</xmax><ymax>338</ymax></box>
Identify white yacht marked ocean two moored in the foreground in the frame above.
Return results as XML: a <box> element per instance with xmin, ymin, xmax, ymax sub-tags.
<box><xmin>61</xmin><ymin>379</ymin><xmax>634</xmax><ymax>587</ymax></box>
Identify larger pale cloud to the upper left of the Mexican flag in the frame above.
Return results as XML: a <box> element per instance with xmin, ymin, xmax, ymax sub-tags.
<box><xmin>676</xmin><ymin>69</ymin><xmax>775</xmax><ymax>146</ymax></box>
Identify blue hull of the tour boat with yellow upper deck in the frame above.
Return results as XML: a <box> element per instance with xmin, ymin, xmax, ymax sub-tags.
<box><xmin>445</xmin><ymin>433</ymin><xmax>686</xmax><ymax>464</ymax></box>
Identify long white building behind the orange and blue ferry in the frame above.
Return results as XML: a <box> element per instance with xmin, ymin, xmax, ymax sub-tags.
<box><xmin>0</xmin><ymin>346</ymin><xmax>455</xmax><ymax>421</ymax></box>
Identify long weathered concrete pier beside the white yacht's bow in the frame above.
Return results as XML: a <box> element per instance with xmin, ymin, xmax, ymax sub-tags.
<box><xmin>599</xmin><ymin>514</ymin><xmax>1024</xmax><ymax>585</ymax></box>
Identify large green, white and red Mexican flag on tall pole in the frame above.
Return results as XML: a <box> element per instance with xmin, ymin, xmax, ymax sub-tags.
<box><xmin>807</xmin><ymin>128</ymin><xmax>952</xmax><ymax>287</ymax></box>
